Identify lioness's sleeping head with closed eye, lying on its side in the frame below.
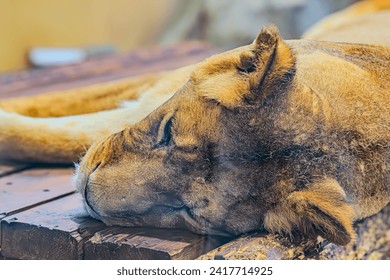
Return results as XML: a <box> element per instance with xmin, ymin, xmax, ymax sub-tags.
<box><xmin>76</xmin><ymin>26</ymin><xmax>358</xmax><ymax>243</ymax></box>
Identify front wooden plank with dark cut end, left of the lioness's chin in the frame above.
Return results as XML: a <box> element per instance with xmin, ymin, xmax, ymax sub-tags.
<box><xmin>1</xmin><ymin>194</ymin><xmax>104</xmax><ymax>260</ymax></box>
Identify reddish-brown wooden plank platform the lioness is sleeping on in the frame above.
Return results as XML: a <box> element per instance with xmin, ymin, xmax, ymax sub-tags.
<box><xmin>0</xmin><ymin>42</ymin><xmax>390</xmax><ymax>259</ymax></box>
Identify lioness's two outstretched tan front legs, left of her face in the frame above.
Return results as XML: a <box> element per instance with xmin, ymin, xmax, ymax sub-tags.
<box><xmin>0</xmin><ymin>66</ymin><xmax>193</xmax><ymax>163</ymax></box>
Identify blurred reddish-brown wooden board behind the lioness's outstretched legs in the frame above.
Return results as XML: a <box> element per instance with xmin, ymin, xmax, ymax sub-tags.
<box><xmin>0</xmin><ymin>42</ymin><xmax>216</xmax><ymax>98</ymax></box>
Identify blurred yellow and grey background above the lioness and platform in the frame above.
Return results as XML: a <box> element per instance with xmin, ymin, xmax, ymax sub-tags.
<box><xmin>0</xmin><ymin>0</ymin><xmax>356</xmax><ymax>72</ymax></box>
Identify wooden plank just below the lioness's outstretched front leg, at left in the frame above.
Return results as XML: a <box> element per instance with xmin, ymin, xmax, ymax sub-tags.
<box><xmin>0</xmin><ymin>168</ymin><xmax>74</xmax><ymax>220</ymax></box>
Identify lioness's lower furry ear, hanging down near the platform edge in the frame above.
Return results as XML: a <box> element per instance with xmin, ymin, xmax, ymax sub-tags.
<box><xmin>264</xmin><ymin>179</ymin><xmax>355</xmax><ymax>245</ymax></box>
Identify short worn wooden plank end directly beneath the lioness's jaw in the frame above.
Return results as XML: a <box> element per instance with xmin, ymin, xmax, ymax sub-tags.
<box><xmin>84</xmin><ymin>227</ymin><xmax>226</xmax><ymax>260</ymax></box>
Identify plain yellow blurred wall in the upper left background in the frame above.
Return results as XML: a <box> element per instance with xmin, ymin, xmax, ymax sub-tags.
<box><xmin>0</xmin><ymin>0</ymin><xmax>180</xmax><ymax>71</ymax></box>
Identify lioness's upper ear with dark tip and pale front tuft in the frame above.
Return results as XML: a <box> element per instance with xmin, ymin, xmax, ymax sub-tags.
<box><xmin>198</xmin><ymin>25</ymin><xmax>295</xmax><ymax>108</ymax></box>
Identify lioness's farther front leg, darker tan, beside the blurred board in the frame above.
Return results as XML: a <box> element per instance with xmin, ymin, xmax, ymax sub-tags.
<box><xmin>0</xmin><ymin>73</ymin><xmax>163</xmax><ymax>118</ymax></box>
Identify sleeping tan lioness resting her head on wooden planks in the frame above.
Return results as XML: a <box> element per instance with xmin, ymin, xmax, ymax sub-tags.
<box><xmin>0</xmin><ymin>9</ymin><xmax>390</xmax><ymax>245</ymax></box>
